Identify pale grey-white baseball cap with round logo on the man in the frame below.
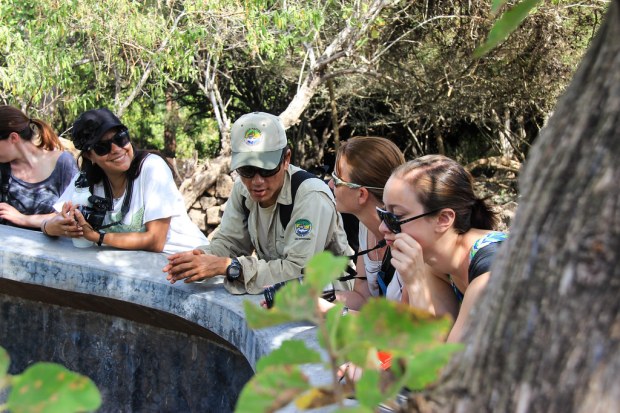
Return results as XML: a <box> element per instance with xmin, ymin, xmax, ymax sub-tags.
<box><xmin>230</xmin><ymin>112</ymin><xmax>287</xmax><ymax>169</ymax></box>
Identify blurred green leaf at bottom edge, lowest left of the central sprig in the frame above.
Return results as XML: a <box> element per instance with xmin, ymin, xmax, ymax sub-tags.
<box><xmin>235</xmin><ymin>366</ymin><xmax>310</xmax><ymax>413</ymax></box>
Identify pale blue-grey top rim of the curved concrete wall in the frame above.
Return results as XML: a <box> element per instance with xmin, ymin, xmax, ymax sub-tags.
<box><xmin>0</xmin><ymin>225</ymin><xmax>330</xmax><ymax>410</ymax></box>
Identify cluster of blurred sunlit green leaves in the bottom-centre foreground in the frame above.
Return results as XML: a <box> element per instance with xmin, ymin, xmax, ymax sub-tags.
<box><xmin>238</xmin><ymin>253</ymin><xmax>462</xmax><ymax>412</ymax></box>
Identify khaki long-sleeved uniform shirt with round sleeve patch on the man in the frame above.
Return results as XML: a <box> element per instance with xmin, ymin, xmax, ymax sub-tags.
<box><xmin>200</xmin><ymin>165</ymin><xmax>353</xmax><ymax>294</ymax></box>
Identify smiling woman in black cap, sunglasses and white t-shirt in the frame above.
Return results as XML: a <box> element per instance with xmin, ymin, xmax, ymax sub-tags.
<box><xmin>46</xmin><ymin>108</ymin><xmax>208</xmax><ymax>253</ymax></box>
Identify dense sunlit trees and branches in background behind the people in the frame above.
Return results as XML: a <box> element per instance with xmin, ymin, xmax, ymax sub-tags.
<box><xmin>0</xmin><ymin>0</ymin><xmax>605</xmax><ymax>166</ymax></box>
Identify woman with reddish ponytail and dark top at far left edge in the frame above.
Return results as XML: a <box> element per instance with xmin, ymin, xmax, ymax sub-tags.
<box><xmin>0</xmin><ymin>105</ymin><xmax>78</xmax><ymax>228</ymax></box>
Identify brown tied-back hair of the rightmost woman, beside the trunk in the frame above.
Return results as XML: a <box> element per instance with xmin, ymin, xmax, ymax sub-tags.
<box><xmin>392</xmin><ymin>155</ymin><xmax>497</xmax><ymax>234</ymax></box>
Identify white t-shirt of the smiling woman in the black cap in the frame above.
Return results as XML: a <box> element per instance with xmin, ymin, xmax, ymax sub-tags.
<box><xmin>54</xmin><ymin>155</ymin><xmax>209</xmax><ymax>254</ymax></box>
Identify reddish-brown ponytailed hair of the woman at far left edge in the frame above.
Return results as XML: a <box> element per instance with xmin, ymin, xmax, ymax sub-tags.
<box><xmin>0</xmin><ymin>105</ymin><xmax>63</xmax><ymax>151</ymax></box>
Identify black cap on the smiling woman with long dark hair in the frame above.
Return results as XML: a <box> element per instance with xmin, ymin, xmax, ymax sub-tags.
<box><xmin>71</xmin><ymin>108</ymin><xmax>127</xmax><ymax>151</ymax></box>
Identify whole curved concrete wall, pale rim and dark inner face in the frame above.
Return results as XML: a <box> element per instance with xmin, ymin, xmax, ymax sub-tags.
<box><xmin>0</xmin><ymin>225</ymin><xmax>329</xmax><ymax>412</ymax></box>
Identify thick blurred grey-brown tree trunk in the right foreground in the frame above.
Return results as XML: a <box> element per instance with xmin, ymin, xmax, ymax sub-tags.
<box><xmin>409</xmin><ymin>0</ymin><xmax>620</xmax><ymax>413</ymax></box>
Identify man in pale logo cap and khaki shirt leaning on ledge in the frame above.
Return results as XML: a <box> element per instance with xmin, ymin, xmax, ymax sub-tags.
<box><xmin>164</xmin><ymin>112</ymin><xmax>352</xmax><ymax>294</ymax></box>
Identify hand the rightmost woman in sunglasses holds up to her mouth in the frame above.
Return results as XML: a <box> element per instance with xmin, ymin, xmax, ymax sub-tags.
<box><xmin>391</xmin><ymin>233</ymin><xmax>426</xmax><ymax>286</ymax></box>
